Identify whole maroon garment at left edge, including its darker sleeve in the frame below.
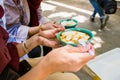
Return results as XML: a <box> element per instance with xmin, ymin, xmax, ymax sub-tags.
<box><xmin>0</xmin><ymin>26</ymin><xmax>19</xmax><ymax>73</ymax></box>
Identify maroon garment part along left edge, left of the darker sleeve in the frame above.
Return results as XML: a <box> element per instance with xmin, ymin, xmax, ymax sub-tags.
<box><xmin>0</xmin><ymin>26</ymin><xmax>11</xmax><ymax>73</ymax></box>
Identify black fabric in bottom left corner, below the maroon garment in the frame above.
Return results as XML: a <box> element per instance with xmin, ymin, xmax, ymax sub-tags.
<box><xmin>0</xmin><ymin>60</ymin><xmax>32</xmax><ymax>80</ymax></box>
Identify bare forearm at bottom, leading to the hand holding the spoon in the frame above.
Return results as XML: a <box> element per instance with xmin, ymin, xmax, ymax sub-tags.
<box><xmin>18</xmin><ymin>60</ymin><xmax>51</xmax><ymax>80</ymax></box>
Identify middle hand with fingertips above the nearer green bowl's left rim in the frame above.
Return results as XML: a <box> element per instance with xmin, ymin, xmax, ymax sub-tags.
<box><xmin>38</xmin><ymin>27</ymin><xmax>65</xmax><ymax>39</ymax></box>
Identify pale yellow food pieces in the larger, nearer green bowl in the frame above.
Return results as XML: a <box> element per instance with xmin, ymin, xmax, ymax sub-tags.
<box><xmin>60</xmin><ymin>30</ymin><xmax>90</xmax><ymax>44</ymax></box>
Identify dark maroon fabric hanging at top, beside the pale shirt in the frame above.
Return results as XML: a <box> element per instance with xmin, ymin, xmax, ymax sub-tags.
<box><xmin>27</xmin><ymin>0</ymin><xmax>42</xmax><ymax>26</ymax></box>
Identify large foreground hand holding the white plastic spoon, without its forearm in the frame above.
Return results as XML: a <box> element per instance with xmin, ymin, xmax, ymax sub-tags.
<box><xmin>39</xmin><ymin>44</ymin><xmax>95</xmax><ymax>73</ymax></box>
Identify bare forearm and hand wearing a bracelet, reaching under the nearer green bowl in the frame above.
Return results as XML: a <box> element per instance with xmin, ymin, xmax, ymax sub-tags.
<box><xmin>17</xmin><ymin>30</ymin><xmax>63</xmax><ymax>57</ymax></box>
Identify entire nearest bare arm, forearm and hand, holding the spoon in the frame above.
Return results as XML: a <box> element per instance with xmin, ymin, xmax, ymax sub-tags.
<box><xmin>19</xmin><ymin>45</ymin><xmax>95</xmax><ymax>80</ymax></box>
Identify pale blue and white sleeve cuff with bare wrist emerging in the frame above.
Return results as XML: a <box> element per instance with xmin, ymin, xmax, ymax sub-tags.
<box><xmin>7</xmin><ymin>23</ymin><xmax>44</xmax><ymax>43</ymax></box>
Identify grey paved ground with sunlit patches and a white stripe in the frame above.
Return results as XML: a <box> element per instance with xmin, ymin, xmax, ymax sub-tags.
<box><xmin>42</xmin><ymin>0</ymin><xmax>120</xmax><ymax>80</ymax></box>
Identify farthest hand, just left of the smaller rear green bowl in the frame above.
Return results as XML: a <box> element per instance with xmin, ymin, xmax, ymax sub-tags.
<box><xmin>41</xmin><ymin>22</ymin><xmax>65</xmax><ymax>30</ymax></box>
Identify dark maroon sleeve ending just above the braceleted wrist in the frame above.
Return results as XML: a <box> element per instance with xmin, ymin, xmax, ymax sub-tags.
<box><xmin>7</xmin><ymin>42</ymin><xmax>19</xmax><ymax>71</ymax></box>
